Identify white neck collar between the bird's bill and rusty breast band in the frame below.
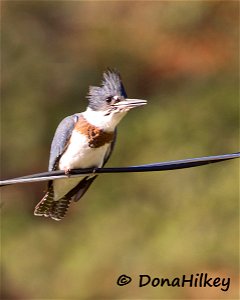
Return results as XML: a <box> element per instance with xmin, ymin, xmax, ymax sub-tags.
<box><xmin>83</xmin><ymin>107</ymin><xmax>126</xmax><ymax>131</ymax></box>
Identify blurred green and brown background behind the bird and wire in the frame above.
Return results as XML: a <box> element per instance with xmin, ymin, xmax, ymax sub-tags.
<box><xmin>1</xmin><ymin>1</ymin><xmax>239</xmax><ymax>299</ymax></box>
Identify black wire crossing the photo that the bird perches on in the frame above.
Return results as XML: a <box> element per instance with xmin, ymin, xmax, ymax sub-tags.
<box><xmin>0</xmin><ymin>152</ymin><xmax>240</xmax><ymax>187</ymax></box>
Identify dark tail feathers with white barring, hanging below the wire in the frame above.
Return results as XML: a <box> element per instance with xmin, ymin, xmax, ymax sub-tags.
<box><xmin>34</xmin><ymin>183</ymin><xmax>71</xmax><ymax>221</ymax></box>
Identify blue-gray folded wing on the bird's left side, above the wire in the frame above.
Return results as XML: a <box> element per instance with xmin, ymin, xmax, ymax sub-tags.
<box><xmin>48</xmin><ymin>114</ymin><xmax>78</xmax><ymax>171</ymax></box>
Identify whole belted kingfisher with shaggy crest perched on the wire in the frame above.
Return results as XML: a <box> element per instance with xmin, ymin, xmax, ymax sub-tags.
<box><xmin>34</xmin><ymin>69</ymin><xmax>147</xmax><ymax>220</ymax></box>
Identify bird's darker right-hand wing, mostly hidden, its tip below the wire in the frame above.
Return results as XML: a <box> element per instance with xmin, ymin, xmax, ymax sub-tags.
<box><xmin>70</xmin><ymin>129</ymin><xmax>117</xmax><ymax>201</ymax></box>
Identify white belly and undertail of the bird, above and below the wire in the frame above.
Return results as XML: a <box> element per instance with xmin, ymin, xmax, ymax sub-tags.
<box><xmin>53</xmin><ymin>131</ymin><xmax>109</xmax><ymax>201</ymax></box>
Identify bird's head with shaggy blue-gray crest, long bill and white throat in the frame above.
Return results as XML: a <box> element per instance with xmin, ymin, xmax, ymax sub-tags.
<box><xmin>86</xmin><ymin>70</ymin><xmax>147</xmax><ymax>129</ymax></box>
